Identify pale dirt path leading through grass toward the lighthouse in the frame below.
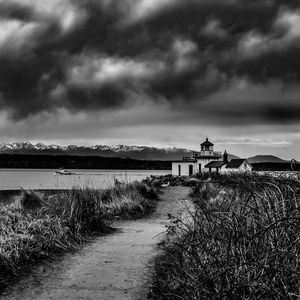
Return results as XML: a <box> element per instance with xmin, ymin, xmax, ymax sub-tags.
<box><xmin>1</xmin><ymin>187</ymin><xmax>192</xmax><ymax>300</ymax></box>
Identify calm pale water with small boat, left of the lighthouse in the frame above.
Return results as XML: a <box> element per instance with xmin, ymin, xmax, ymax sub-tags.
<box><xmin>0</xmin><ymin>169</ymin><xmax>171</xmax><ymax>190</ymax></box>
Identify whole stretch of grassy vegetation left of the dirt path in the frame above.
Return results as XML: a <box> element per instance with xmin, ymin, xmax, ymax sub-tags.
<box><xmin>0</xmin><ymin>182</ymin><xmax>158</xmax><ymax>290</ymax></box>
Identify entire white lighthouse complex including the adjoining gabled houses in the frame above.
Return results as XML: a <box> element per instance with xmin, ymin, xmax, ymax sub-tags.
<box><xmin>172</xmin><ymin>138</ymin><xmax>253</xmax><ymax>176</ymax></box>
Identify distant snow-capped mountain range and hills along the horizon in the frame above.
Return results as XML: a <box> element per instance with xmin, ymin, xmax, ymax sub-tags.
<box><xmin>0</xmin><ymin>142</ymin><xmax>284</xmax><ymax>163</ymax></box>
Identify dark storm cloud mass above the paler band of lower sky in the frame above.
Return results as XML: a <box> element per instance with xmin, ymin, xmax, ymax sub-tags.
<box><xmin>0</xmin><ymin>0</ymin><xmax>300</xmax><ymax>124</ymax></box>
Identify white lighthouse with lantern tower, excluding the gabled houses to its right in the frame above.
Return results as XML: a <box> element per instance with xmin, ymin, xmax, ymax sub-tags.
<box><xmin>172</xmin><ymin>138</ymin><xmax>223</xmax><ymax>176</ymax></box>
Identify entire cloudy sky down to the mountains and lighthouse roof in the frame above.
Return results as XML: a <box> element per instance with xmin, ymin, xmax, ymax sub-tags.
<box><xmin>0</xmin><ymin>0</ymin><xmax>300</xmax><ymax>159</ymax></box>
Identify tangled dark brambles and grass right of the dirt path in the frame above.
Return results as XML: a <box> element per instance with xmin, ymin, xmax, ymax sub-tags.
<box><xmin>152</xmin><ymin>174</ymin><xmax>300</xmax><ymax>299</ymax></box>
